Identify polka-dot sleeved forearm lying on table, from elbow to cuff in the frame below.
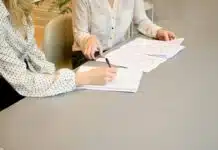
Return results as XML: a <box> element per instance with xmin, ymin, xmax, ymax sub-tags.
<box><xmin>2</xmin><ymin>69</ymin><xmax>76</xmax><ymax>97</ymax></box>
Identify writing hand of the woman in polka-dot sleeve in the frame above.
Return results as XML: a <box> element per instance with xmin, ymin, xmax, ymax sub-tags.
<box><xmin>76</xmin><ymin>67</ymin><xmax>117</xmax><ymax>86</ymax></box>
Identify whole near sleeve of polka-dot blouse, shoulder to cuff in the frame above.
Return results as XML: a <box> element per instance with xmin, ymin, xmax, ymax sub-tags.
<box><xmin>0</xmin><ymin>27</ymin><xmax>76</xmax><ymax>97</ymax></box>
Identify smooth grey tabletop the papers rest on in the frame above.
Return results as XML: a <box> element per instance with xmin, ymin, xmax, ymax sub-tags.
<box><xmin>0</xmin><ymin>0</ymin><xmax>218</xmax><ymax>150</ymax></box>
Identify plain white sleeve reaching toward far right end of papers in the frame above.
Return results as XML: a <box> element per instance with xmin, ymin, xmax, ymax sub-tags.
<box><xmin>133</xmin><ymin>0</ymin><xmax>161</xmax><ymax>38</ymax></box>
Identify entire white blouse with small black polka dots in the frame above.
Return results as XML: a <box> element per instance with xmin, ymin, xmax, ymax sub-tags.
<box><xmin>0</xmin><ymin>0</ymin><xmax>76</xmax><ymax>97</ymax></box>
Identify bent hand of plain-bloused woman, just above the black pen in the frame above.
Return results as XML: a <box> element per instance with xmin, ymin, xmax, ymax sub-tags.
<box><xmin>83</xmin><ymin>36</ymin><xmax>100</xmax><ymax>59</ymax></box>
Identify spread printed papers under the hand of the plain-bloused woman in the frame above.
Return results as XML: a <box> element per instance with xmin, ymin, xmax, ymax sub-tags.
<box><xmin>97</xmin><ymin>38</ymin><xmax>184</xmax><ymax>72</ymax></box>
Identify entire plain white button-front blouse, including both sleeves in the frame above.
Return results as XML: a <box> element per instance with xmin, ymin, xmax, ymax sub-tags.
<box><xmin>73</xmin><ymin>0</ymin><xmax>160</xmax><ymax>51</ymax></box>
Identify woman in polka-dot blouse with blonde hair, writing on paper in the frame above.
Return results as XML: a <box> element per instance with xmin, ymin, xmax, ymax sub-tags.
<box><xmin>0</xmin><ymin>0</ymin><xmax>116</xmax><ymax>110</ymax></box>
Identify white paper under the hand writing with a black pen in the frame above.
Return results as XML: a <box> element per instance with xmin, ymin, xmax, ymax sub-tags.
<box><xmin>78</xmin><ymin>66</ymin><xmax>143</xmax><ymax>93</ymax></box>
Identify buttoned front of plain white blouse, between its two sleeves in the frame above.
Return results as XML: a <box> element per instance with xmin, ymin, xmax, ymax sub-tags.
<box><xmin>88</xmin><ymin>0</ymin><xmax>134</xmax><ymax>49</ymax></box>
